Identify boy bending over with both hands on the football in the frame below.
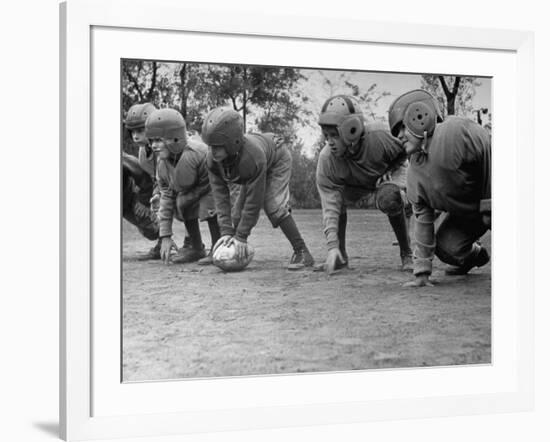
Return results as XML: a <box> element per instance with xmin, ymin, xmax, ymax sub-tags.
<box><xmin>202</xmin><ymin>107</ymin><xmax>314</xmax><ymax>270</ymax></box>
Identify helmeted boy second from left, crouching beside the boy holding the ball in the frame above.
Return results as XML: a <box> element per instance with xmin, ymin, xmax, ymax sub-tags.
<box><xmin>145</xmin><ymin>109</ymin><xmax>220</xmax><ymax>264</ymax></box>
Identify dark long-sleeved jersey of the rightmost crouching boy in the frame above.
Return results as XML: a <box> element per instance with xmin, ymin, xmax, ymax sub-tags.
<box><xmin>407</xmin><ymin>117</ymin><xmax>491</xmax><ymax>275</ymax></box>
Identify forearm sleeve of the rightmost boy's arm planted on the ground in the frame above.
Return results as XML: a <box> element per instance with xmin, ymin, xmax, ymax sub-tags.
<box><xmin>413</xmin><ymin>203</ymin><xmax>435</xmax><ymax>275</ymax></box>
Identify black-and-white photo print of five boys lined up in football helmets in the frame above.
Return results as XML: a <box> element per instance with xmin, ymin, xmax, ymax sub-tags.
<box><xmin>123</xmin><ymin>59</ymin><xmax>492</xmax><ymax>382</ymax></box>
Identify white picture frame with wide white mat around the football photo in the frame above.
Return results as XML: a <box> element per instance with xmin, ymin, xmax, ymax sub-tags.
<box><xmin>60</xmin><ymin>0</ymin><xmax>534</xmax><ymax>440</ymax></box>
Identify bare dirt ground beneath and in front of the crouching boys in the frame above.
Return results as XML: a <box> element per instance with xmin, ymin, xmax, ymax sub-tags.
<box><xmin>122</xmin><ymin>210</ymin><xmax>491</xmax><ymax>381</ymax></box>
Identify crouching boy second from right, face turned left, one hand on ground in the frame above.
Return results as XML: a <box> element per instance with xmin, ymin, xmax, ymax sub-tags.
<box><xmin>317</xmin><ymin>95</ymin><xmax>412</xmax><ymax>274</ymax></box>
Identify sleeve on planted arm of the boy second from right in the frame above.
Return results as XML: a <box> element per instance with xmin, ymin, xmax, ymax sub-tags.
<box><xmin>316</xmin><ymin>148</ymin><xmax>344</xmax><ymax>250</ymax></box>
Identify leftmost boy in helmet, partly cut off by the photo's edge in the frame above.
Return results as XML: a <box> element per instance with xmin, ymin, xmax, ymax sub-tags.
<box><xmin>122</xmin><ymin>103</ymin><xmax>160</xmax><ymax>259</ymax></box>
